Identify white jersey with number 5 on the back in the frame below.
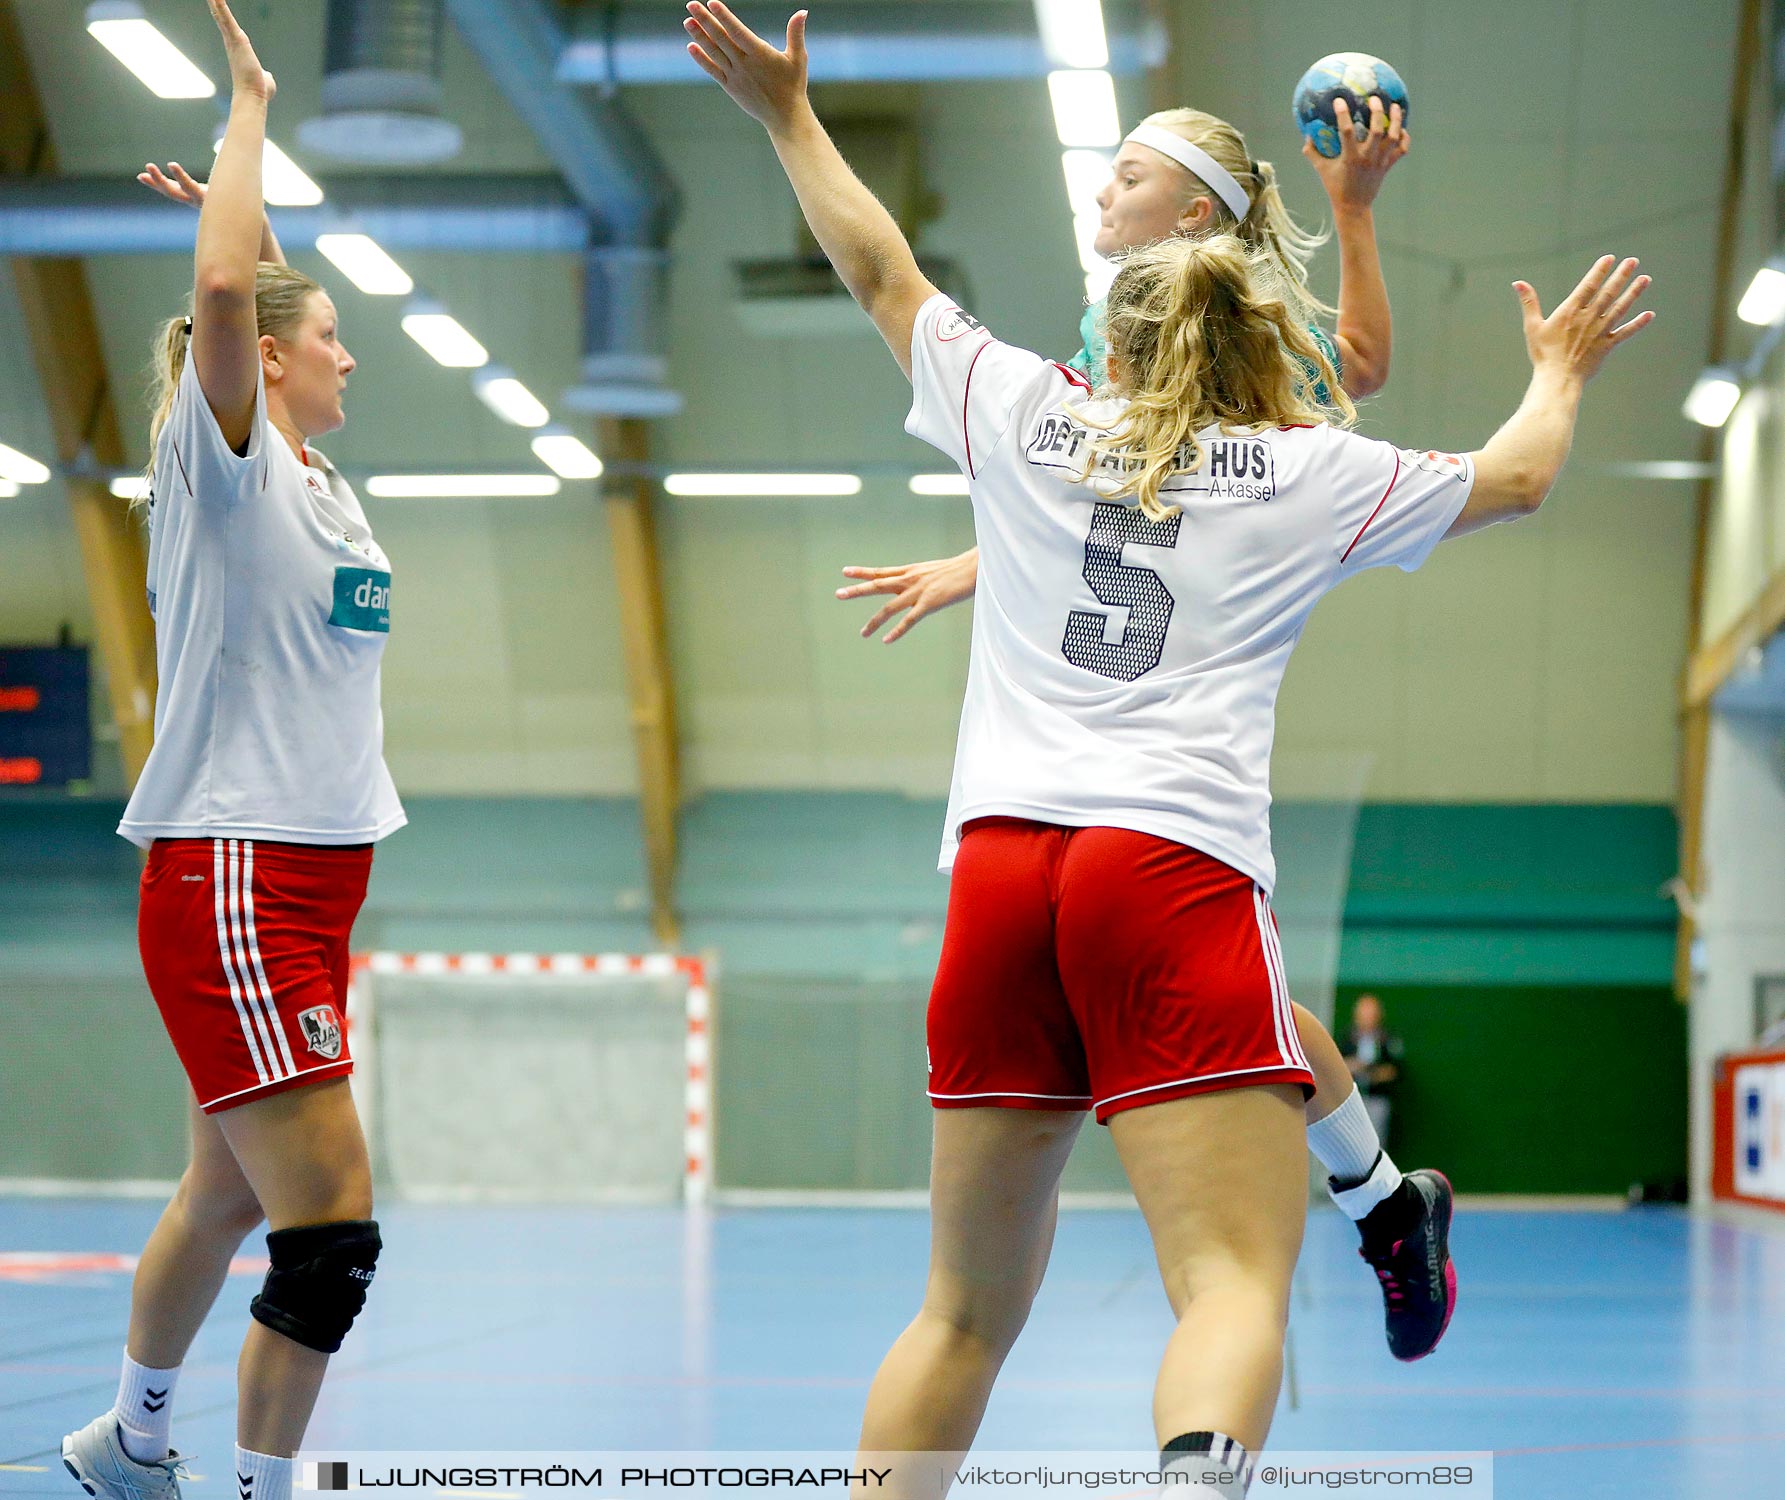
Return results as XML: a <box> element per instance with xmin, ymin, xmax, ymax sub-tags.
<box><xmin>905</xmin><ymin>296</ymin><xmax>1474</xmax><ymax>891</ymax></box>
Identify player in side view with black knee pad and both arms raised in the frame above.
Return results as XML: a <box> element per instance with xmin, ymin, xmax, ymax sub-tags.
<box><xmin>62</xmin><ymin>0</ymin><xmax>403</xmax><ymax>1500</ymax></box>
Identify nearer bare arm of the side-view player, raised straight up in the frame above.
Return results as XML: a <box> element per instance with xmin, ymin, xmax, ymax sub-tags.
<box><xmin>193</xmin><ymin>0</ymin><xmax>273</xmax><ymax>448</ymax></box>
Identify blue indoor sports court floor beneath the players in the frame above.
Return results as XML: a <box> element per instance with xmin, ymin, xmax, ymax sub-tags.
<box><xmin>0</xmin><ymin>1198</ymin><xmax>1785</xmax><ymax>1500</ymax></box>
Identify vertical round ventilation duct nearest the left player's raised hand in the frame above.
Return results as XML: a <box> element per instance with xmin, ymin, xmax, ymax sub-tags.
<box><xmin>298</xmin><ymin>0</ymin><xmax>464</xmax><ymax>166</ymax></box>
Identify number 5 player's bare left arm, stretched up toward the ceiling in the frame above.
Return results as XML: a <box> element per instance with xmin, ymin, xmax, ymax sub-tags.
<box><xmin>682</xmin><ymin>0</ymin><xmax>935</xmax><ymax>377</ymax></box>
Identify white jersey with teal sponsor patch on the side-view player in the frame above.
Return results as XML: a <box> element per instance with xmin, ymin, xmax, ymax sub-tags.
<box><xmin>118</xmin><ymin>348</ymin><xmax>405</xmax><ymax>848</ymax></box>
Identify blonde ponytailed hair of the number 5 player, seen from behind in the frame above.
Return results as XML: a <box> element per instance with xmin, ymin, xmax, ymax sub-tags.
<box><xmin>1075</xmin><ymin>234</ymin><xmax>1357</xmax><ymax>520</ymax></box>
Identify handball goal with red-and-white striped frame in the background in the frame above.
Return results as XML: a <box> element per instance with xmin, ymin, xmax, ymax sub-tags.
<box><xmin>348</xmin><ymin>954</ymin><xmax>712</xmax><ymax>1204</ymax></box>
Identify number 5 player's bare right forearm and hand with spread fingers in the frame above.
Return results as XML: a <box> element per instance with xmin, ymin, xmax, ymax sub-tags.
<box><xmin>1444</xmin><ymin>255</ymin><xmax>1655</xmax><ymax>539</ymax></box>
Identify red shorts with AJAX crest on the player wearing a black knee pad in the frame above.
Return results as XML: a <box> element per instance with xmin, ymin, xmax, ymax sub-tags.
<box><xmin>136</xmin><ymin>839</ymin><xmax>371</xmax><ymax>1114</ymax></box>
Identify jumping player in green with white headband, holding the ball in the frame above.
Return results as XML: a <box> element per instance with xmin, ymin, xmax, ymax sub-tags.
<box><xmin>837</xmin><ymin>76</ymin><xmax>1457</xmax><ymax>1361</ymax></box>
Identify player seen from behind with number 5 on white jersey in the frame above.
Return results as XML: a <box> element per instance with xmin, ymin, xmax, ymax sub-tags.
<box><xmin>685</xmin><ymin>4</ymin><xmax>1651</xmax><ymax>1488</ymax></box>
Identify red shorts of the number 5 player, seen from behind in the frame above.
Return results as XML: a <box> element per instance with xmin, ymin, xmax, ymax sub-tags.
<box><xmin>928</xmin><ymin>818</ymin><xmax>1314</xmax><ymax>1123</ymax></box>
